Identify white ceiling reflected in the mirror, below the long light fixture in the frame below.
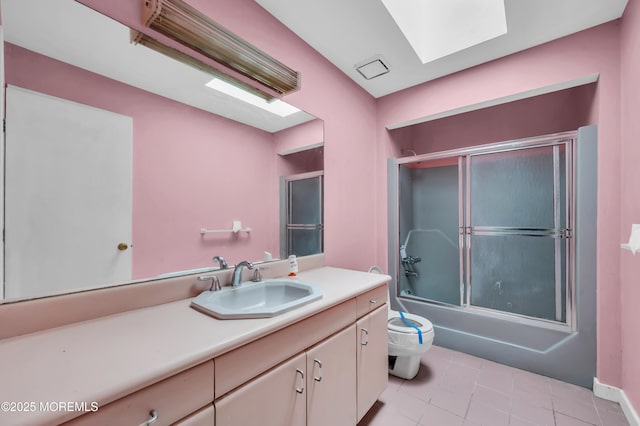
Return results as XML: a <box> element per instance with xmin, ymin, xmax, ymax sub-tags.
<box><xmin>2</xmin><ymin>0</ymin><xmax>315</xmax><ymax>133</ymax></box>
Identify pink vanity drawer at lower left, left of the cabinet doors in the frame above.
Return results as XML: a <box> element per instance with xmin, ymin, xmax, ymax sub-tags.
<box><xmin>65</xmin><ymin>360</ymin><xmax>213</xmax><ymax>426</ymax></box>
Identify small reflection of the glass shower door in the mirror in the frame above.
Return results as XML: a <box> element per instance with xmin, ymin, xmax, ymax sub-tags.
<box><xmin>285</xmin><ymin>172</ymin><xmax>324</xmax><ymax>256</ymax></box>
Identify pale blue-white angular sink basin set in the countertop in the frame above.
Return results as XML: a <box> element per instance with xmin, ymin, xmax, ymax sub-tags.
<box><xmin>191</xmin><ymin>278</ymin><xmax>322</xmax><ymax>319</ymax></box>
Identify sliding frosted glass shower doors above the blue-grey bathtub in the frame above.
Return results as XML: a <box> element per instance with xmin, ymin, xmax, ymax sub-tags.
<box><xmin>398</xmin><ymin>138</ymin><xmax>572</xmax><ymax>324</ymax></box>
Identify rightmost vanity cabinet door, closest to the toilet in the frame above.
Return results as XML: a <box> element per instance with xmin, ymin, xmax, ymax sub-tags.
<box><xmin>356</xmin><ymin>304</ymin><xmax>389</xmax><ymax>421</ymax></box>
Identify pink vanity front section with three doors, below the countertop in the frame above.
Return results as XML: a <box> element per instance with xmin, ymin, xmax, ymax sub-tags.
<box><xmin>214</xmin><ymin>285</ymin><xmax>388</xmax><ymax>426</ymax></box>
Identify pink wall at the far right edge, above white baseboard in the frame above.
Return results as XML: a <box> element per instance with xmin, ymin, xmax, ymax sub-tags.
<box><xmin>620</xmin><ymin>0</ymin><xmax>640</xmax><ymax>411</ymax></box>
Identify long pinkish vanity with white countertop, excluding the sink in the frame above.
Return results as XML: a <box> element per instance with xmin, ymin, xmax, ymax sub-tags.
<box><xmin>0</xmin><ymin>263</ymin><xmax>388</xmax><ymax>426</ymax></box>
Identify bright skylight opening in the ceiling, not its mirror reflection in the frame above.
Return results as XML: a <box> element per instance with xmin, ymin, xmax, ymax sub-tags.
<box><xmin>382</xmin><ymin>0</ymin><xmax>507</xmax><ymax>64</ymax></box>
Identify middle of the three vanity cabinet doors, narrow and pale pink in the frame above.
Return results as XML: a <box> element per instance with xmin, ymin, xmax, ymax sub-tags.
<box><xmin>307</xmin><ymin>324</ymin><xmax>356</xmax><ymax>426</ymax></box>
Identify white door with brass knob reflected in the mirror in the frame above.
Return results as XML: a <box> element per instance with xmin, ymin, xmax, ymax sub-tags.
<box><xmin>5</xmin><ymin>86</ymin><xmax>133</xmax><ymax>298</ymax></box>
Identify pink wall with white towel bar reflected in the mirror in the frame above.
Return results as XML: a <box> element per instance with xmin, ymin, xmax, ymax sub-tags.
<box><xmin>5</xmin><ymin>43</ymin><xmax>278</xmax><ymax>279</ymax></box>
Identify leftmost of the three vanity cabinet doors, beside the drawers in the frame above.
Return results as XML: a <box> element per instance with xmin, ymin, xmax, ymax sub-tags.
<box><xmin>215</xmin><ymin>353</ymin><xmax>307</xmax><ymax>426</ymax></box>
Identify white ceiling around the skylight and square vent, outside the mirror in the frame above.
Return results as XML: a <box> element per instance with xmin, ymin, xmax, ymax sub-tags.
<box><xmin>255</xmin><ymin>0</ymin><xmax>628</xmax><ymax>97</ymax></box>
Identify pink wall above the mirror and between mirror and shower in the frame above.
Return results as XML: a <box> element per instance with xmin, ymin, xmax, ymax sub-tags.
<box><xmin>81</xmin><ymin>0</ymin><xmax>385</xmax><ymax>270</ymax></box>
